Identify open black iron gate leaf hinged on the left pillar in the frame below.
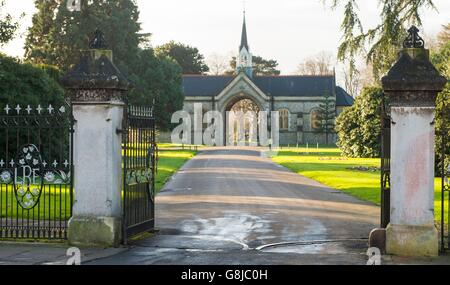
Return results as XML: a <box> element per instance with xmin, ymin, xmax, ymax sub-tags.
<box><xmin>122</xmin><ymin>106</ymin><xmax>158</xmax><ymax>243</ymax></box>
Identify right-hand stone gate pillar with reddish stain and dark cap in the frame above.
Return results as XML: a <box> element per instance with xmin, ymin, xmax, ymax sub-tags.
<box><xmin>382</xmin><ymin>26</ymin><xmax>447</xmax><ymax>256</ymax></box>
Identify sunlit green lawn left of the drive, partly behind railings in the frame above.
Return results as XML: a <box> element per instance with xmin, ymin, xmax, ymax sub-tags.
<box><xmin>0</xmin><ymin>145</ymin><xmax>196</xmax><ymax>220</ymax></box>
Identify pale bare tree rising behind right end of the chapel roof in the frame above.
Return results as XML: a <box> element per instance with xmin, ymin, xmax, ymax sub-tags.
<box><xmin>297</xmin><ymin>51</ymin><xmax>334</xmax><ymax>75</ymax></box>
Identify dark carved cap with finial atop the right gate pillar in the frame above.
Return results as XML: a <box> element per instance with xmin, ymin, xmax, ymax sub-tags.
<box><xmin>381</xmin><ymin>27</ymin><xmax>447</xmax><ymax>107</ymax></box>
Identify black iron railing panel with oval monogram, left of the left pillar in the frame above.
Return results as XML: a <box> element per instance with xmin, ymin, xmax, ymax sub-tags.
<box><xmin>0</xmin><ymin>104</ymin><xmax>73</xmax><ymax>239</ymax></box>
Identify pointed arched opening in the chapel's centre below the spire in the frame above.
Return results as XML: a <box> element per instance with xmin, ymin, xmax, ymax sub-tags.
<box><xmin>224</xmin><ymin>96</ymin><xmax>261</xmax><ymax>145</ymax></box>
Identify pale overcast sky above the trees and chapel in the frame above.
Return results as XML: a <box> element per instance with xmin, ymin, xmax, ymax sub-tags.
<box><xmin>1</xmin><ymin>0</ymin><xmax>450</xmax><ymax>77</ymax></box>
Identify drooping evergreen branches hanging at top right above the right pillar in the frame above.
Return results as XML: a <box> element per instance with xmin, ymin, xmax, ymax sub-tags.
<box><xmin>325</xmin><ymin>0</ymin><xmax>435</xmax><ymax>81</ymax></box>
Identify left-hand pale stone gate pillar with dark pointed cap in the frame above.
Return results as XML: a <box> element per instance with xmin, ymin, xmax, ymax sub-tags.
<box><xmin>62</xmin><ymin>31</ymin><xmax>129</xmax><ymax>246</ymax></box>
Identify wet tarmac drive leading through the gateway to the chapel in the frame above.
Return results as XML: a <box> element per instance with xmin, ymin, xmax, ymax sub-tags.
<box><xmin>92</xmin><ymin>148</ymin><xmax>379</xmax><ymax>265</ymax></box>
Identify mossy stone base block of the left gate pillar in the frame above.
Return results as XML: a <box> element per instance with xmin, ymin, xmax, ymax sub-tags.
<box><xmin>68</xmin><ymin>217</ymin><xmax>122</xmax><ymax>247</ymax></box>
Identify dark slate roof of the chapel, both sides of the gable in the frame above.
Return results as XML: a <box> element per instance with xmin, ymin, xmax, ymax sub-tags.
<box><xmin>183</xmin><ymin>75</ymin><xmax>335</xmax><ymax>97</ymax></box>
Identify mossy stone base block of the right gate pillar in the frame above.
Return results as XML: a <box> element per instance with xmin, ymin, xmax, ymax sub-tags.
<box><xmin>386</xmin><ymin>225</ymin><xmax>439</xmax><ymax>257</ymax></box>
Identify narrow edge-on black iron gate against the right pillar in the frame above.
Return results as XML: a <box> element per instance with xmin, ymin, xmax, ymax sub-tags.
<box><xmin>381</xmin><ymin>94</ymin><xmax>391</xmax><ymax>228</ymax></box>
